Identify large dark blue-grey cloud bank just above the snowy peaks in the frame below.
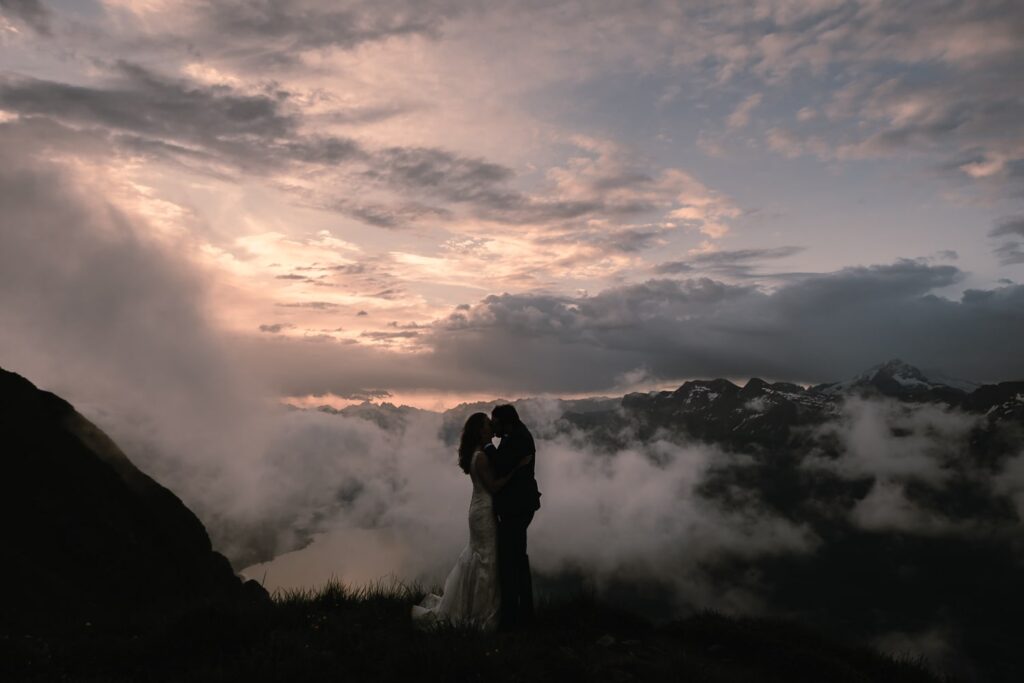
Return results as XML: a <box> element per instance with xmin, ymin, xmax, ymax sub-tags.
<box><xmin>407</xmin><ymin>261</ymin><xmax>1024</xmax><ymax>391</ymax></box>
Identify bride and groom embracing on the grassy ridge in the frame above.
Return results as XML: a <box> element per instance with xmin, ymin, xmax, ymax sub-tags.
<box><xmin>413</xmin><ymin>405</ymin><xmax>541</xmax><ymax>631</ymax></box>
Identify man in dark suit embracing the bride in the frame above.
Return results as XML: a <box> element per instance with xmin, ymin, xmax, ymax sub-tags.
<box><xmin>486</xmin><ymin>404</ymin><xmax>541</xmax><ymax>630</ymax></box>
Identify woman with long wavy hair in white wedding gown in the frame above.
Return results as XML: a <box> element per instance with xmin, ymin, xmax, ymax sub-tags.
<box><xmin>413</xmin><ymin>413</ymin><xmax>532</xmax><ymax>631</ymax></box>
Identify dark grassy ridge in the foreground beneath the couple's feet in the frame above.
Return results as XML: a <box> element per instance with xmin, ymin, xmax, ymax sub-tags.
<box><xmin>0</xmin><ymin>584</ymin><xmax>954</xmax><ymax>683</ymax></box>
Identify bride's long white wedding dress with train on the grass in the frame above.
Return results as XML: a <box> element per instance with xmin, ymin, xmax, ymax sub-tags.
<box><xmin>413</xmin><ymin>451</ymin><xmax>501</xmax><ymax>631</ymax></box>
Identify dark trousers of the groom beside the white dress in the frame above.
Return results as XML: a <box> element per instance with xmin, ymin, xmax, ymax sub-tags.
<box><xmin>498</xmin><ymin>512</ymin><xmax>534</xmax><ymax>629</ymax></box>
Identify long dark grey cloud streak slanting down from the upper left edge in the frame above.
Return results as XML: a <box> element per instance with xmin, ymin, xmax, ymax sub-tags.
<box><xmin>0</xmin><ymin>61</ymin><xmax>487</xmax><ymax>226</ymax></box>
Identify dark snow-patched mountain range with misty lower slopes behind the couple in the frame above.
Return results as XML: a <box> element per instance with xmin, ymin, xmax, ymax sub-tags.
<box><xmin>321</xmin><ymin>359</ymin><xmax>1024</xmax><ymax>681</ymax></box>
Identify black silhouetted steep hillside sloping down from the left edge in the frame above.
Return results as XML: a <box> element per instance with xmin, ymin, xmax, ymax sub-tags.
<box><xmin>0</xmin><ymin>369</ymin><xmax>267</xmax><ymax>630</ymax></box>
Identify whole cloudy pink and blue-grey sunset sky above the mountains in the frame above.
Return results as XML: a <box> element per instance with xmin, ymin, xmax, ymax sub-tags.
<box><xmin>0</xmin><ymin>0</ymin><xmax>1024</xmax><ymax>408</ymax></box>
